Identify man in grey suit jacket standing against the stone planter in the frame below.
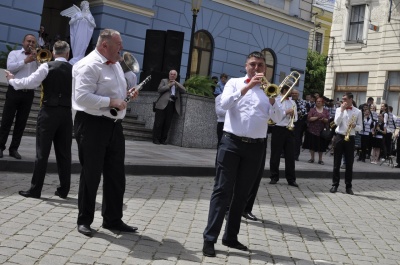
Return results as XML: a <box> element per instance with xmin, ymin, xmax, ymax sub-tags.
<box><xmin>153</xmin><ymin>70</ymin><xmax>186</xmax><ymax>144</ymax></box>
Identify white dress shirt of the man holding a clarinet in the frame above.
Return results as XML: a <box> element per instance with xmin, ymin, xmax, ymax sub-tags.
<box><xmin>72</xmin><ymin>49</ymin><xmax>127</xmax><ymax>119</ymax></box>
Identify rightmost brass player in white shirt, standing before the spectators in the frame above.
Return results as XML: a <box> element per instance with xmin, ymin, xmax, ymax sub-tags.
<box><xmin>330</xmin><ymin>92</ymin><xmax>362</xmax><ymax>195</ymax></box>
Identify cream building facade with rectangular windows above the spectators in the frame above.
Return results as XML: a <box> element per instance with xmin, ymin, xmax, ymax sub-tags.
<box><xmin>325</xmin><ymin>0</ymin><xmax>400</xmax><ymax>114</ymax></box>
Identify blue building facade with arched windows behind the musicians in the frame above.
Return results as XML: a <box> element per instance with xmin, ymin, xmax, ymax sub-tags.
<box><xmin>0</xmin><ymin>0</ymin><xmax>313</xmax><ymax>91</ymax></box>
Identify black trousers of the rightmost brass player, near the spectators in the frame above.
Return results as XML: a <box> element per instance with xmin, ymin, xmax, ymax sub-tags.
<box><xmin>332</xmin><ymin>134</ymin><xmax>355</xmax><ymax>188</ymax></box>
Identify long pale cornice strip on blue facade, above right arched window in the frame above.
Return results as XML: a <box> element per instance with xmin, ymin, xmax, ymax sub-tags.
<box><xmin>213</xmin><ymin>0</ymin><xmax>314</xmax><ymax>31</ymax></box>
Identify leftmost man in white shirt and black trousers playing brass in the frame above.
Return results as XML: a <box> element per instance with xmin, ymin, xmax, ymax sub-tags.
<box><xmin>0</xmin><ymin>34</ymin><xmax>39</xmax><ymax>159</ymax></box>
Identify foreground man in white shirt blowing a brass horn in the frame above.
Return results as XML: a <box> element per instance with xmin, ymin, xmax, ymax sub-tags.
<box><xmin>203</xmin><ymin>52</ymin><xmax>275</xmax><ymax>257</ymax></box>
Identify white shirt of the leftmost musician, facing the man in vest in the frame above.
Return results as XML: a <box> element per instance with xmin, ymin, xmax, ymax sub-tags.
<box><xmin>7</xmin><ymin>48</ymin><xmax>40</xmax><ymax>86</ymax></box>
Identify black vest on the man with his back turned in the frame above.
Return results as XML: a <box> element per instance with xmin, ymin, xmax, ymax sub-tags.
<box><xmin>41</xmin><ymin>61</ymin><xmax>72</xmax><ymax>107</ymax></box>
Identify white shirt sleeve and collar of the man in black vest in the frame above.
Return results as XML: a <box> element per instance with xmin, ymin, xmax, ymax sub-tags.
<box><xmin>9</xmin><ymin>57</ymin><xmax>67</xmax><ymax>90</ymax></box>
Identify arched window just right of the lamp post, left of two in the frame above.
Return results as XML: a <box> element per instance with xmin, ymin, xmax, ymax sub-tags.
<box><xmin>190</xmin><ymin>30</ymin><xmax>214</xmax><ymax>76</ymax></box>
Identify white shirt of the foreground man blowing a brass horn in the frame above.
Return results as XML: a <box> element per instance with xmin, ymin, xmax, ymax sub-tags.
<box><xmin>221</xmin><ymin>76</ymin><xmax>273</xmax><ymax>139</ymax></box>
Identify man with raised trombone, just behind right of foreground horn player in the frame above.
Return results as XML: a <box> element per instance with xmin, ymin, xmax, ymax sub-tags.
<box><xmin>269</xmin><ymin>82</ymin><xmax>299</xmax><ymax>187</ymax></box>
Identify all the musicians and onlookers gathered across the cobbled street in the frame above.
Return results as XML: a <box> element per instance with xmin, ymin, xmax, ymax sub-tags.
<box><xmin>0</xmin><ymin>25</ymin><xmax>400</xmax><ymax>257</ymax></box>
